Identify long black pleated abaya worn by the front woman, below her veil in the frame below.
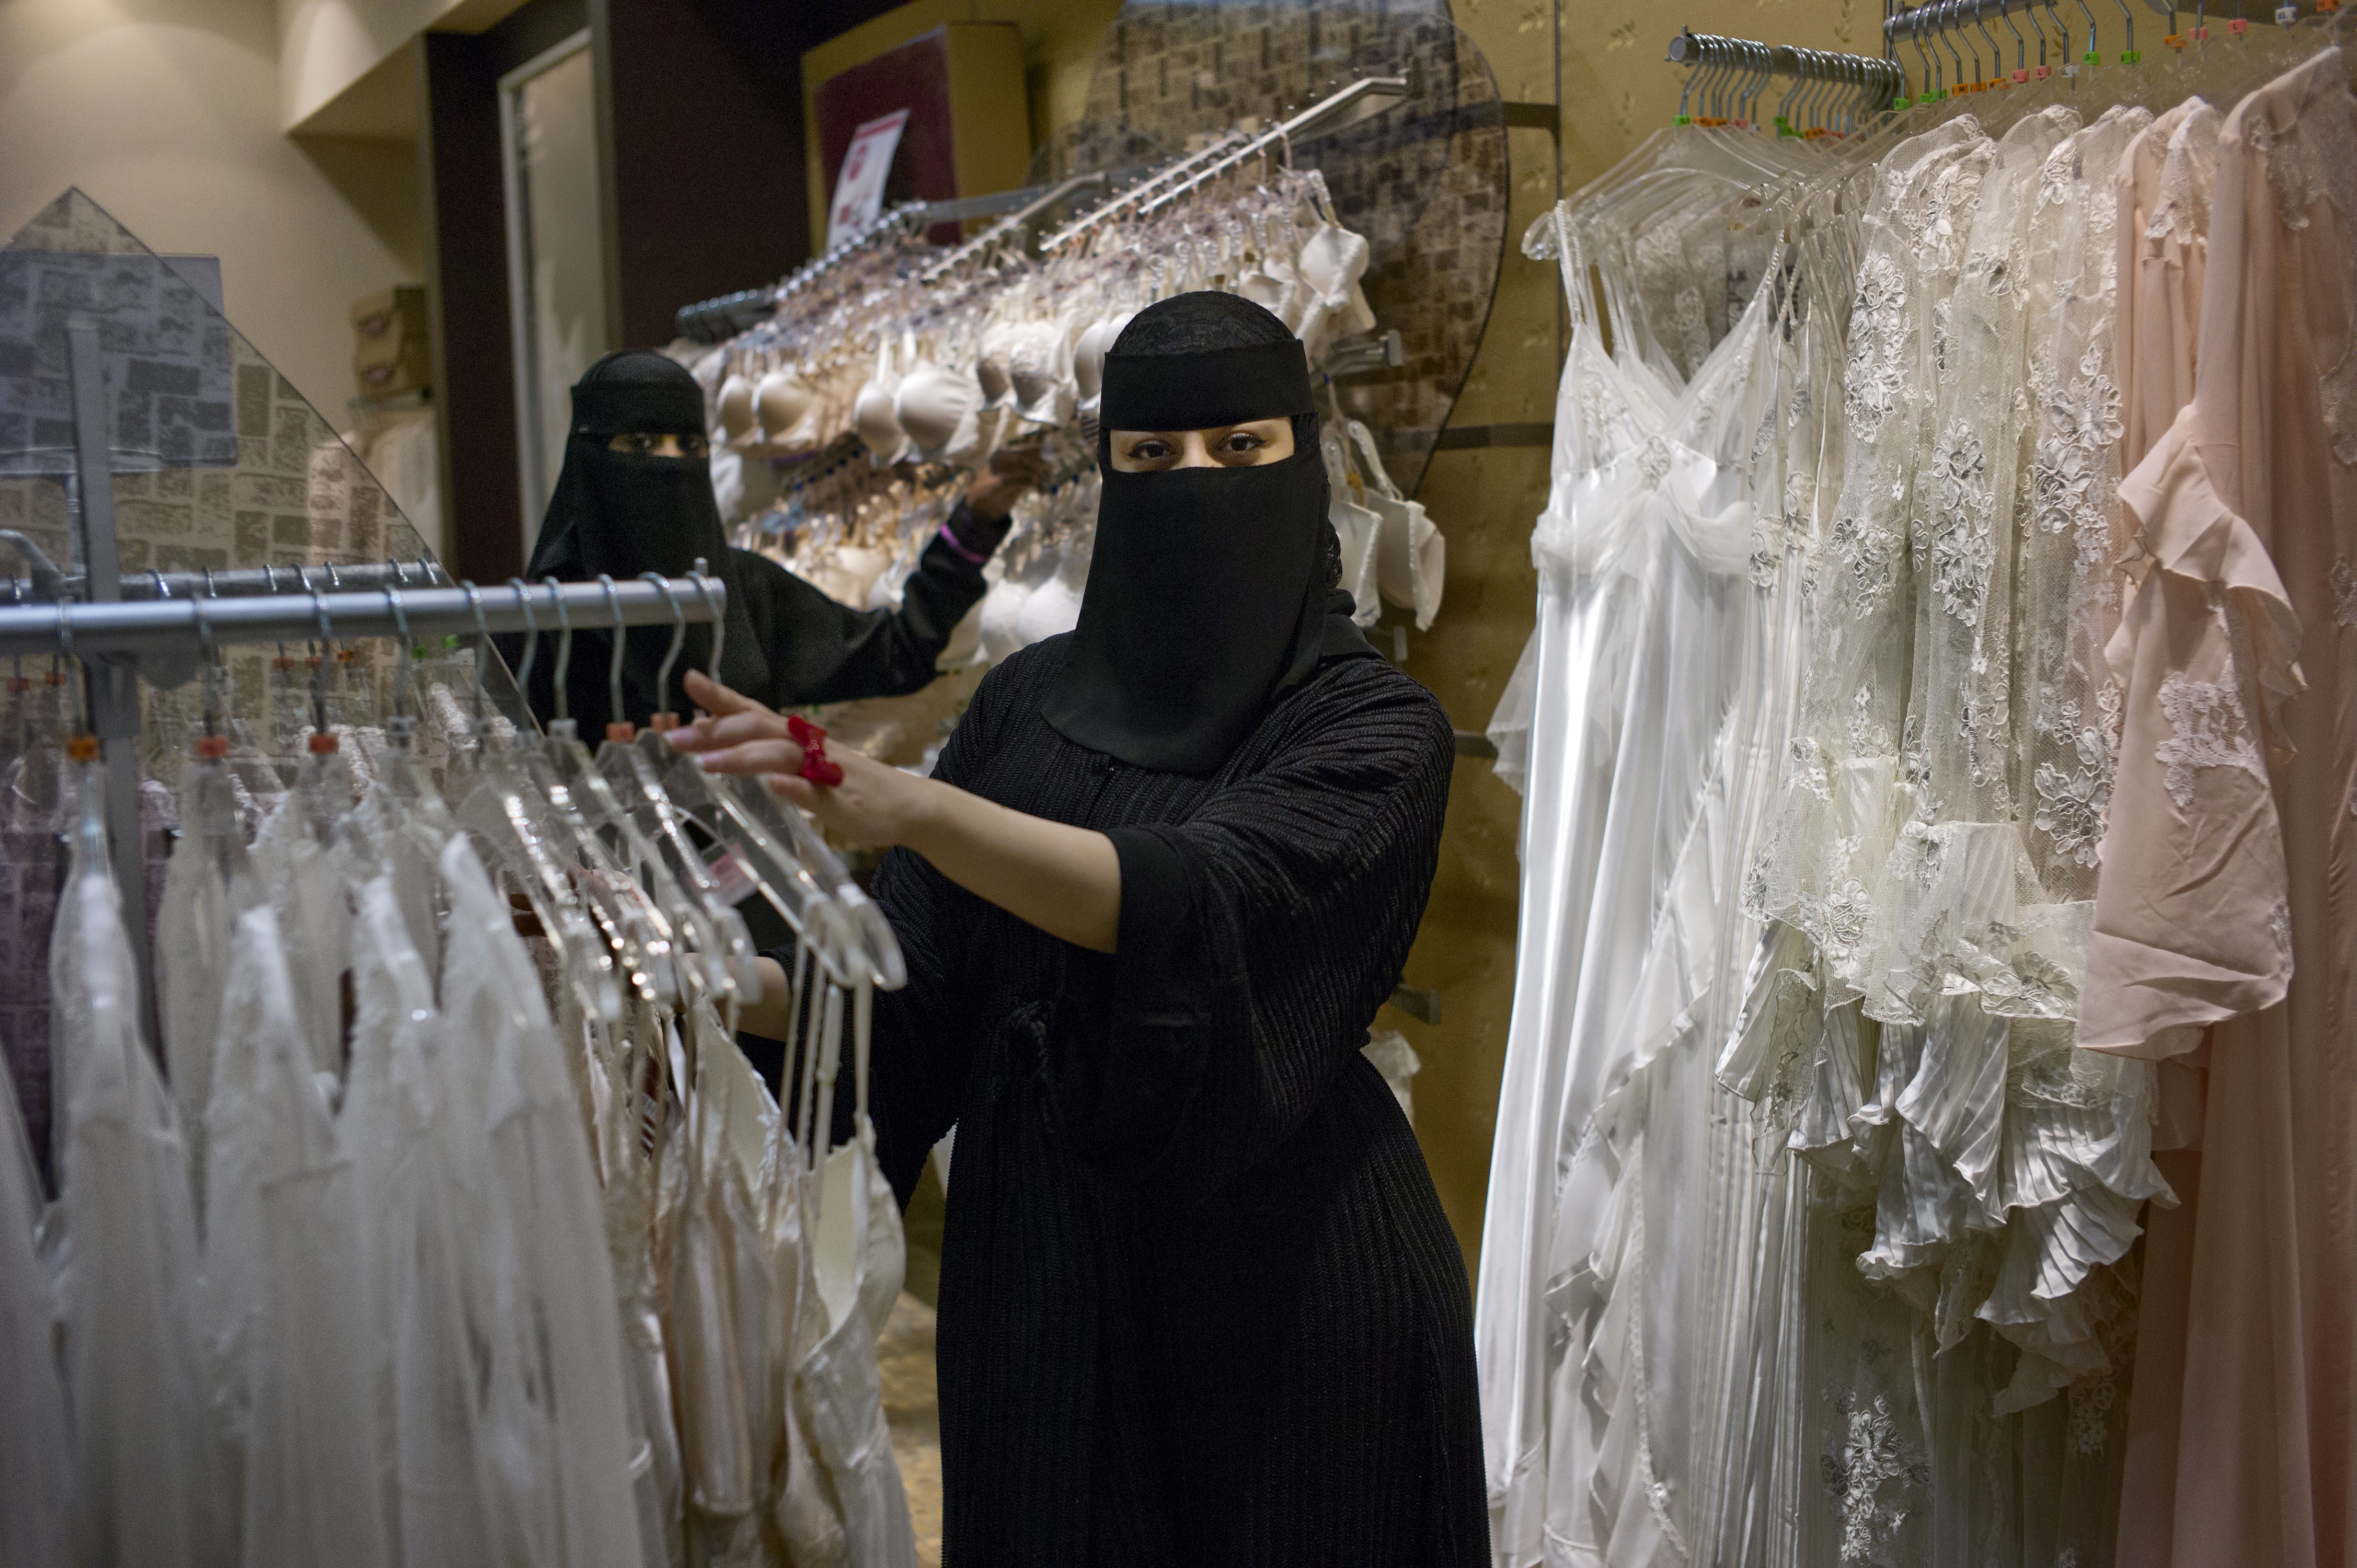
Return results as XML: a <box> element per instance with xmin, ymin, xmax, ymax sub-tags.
<box><xmin>773</xmin><ymin>637</ymin><xmax>1490</xmax><ymax>1568</ymax></box>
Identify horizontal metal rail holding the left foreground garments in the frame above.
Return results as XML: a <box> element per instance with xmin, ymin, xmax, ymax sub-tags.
<box><xmin>0</xmin><ymin>578</ymin><xmax>728</xmax><ymax>667</ymax></box>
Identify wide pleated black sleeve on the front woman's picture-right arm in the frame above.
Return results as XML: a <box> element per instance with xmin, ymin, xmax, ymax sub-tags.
<box><xmin>1051</xmin><ymin>663</ymin><xmax>1454</xmax><ymax>1191</ymax></box>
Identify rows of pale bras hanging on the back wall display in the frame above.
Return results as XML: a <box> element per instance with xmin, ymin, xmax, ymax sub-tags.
<box><xmin>686</xmin><ymin>80</ymin><xmax>1445</xmax><ymax>667</ymax></box>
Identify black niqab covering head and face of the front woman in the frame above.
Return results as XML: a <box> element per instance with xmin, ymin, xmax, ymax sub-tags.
<box><xmin>1044</xmin><ymin>292</ymin><xmax>1374</xmax><ymax>776</ymax></box>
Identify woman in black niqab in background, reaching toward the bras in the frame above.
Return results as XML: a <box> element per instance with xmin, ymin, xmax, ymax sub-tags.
<box><xmin>504</xmin><ymin>349</ymin><xmax>1028</xmax><ymax>738</ymax></box>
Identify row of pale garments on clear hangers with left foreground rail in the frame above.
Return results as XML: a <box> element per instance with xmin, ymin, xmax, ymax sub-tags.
<box><xmin>0</xmin><ymin>575</ymin><xmax>914</xmax><ymax>1568</ymax></box>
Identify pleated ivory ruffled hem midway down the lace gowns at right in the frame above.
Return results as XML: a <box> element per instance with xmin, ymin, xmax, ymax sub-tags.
<box><xmin>1718</xmin><ymin>905</ymin><xmax>2176</xmax><ymax>1408</ymax></box>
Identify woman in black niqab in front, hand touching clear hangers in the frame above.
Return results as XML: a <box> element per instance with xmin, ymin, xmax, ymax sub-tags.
<box><xmin>674</xmin><ymin>295</ymin><xmax>1490</xmax><ymax>1568</ymax></box>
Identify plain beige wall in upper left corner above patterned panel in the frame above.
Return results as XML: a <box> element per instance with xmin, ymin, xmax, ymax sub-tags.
<box><xmin>0</xmin><ymin>0</ymin><xmax>424</xmax><ymax>427</ymax></box>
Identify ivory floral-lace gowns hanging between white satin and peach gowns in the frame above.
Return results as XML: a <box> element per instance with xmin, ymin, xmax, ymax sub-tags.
<box><xmin>1721</xmin><ymin>111</ymin><xmax>2166</xmax><ymax>1565</ymax></box>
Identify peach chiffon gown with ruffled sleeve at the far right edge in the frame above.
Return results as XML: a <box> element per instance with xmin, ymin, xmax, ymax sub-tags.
<box><xmin>2079</xmin><ymin>50</ymin><xmax>2357</xmax><ymax>1568</ymax></box>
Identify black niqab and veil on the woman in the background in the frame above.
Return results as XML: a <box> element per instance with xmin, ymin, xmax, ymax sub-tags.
<box><xmin>509</xmin><ymin>349</ymin><xmax>768</xmax><ymax>741</ymax></box>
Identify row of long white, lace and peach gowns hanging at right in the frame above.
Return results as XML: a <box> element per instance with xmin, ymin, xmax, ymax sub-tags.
<box><xmin>1478</xmin><ymin>18</ymin><xmax>2357</xmax><ymax>1568</ymax></box>
